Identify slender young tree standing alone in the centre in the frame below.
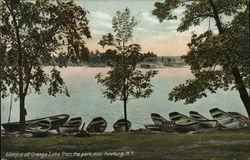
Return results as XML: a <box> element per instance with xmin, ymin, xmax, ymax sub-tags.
<box><xmin>96</xmin><ymin>8</ymin><xmax>157</xmax><ymax>131</ymax></box>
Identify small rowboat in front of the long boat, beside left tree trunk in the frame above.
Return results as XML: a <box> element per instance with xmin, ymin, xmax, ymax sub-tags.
<box><xmin>25</xmin><ymin>120</ymin><xmax>51</xmax><ymax>137</ymax></box>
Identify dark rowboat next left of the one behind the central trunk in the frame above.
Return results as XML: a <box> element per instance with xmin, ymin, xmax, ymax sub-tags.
<box><xmin>86</xmin><ymin>117</ymin><xmax>107</xmax><ymax>133</ymax></box>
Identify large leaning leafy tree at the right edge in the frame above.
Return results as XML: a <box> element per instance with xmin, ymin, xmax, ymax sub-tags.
<box><xmin>153</xmin><ymin>0</ymin><xmax>250</xmax><ymax>117</ymax></box>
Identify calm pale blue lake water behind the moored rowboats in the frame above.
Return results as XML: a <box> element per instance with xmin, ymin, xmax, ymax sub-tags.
<box><xmin>1</xmin><ymin>67</ymin><xmax>246</xmax><ymax>131</ymax></box>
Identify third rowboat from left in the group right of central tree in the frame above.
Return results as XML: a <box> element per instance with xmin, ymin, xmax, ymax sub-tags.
<box><xmin>189</xmin><ymin>111</ymin><xmax>219</xmax><ymax>129</ymax></box>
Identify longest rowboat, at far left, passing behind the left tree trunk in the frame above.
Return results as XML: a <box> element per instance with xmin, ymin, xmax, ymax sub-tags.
<box><xmin>1</xmin><ymin>114</ymin><xmax>69</xmax><ymax>132</ymax></box>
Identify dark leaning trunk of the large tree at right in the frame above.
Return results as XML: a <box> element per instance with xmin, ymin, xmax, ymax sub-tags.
<box><xmin>208</xmin><ymin>0</ymin><xmax>250</xmax><ymax>118</ymax></box>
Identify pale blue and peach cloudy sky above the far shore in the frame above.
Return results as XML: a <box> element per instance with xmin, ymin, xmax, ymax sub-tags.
<box><xmin>75</xmin><ymin>0</ymin><xmax>215</xmax><ymax>56</ymax></box>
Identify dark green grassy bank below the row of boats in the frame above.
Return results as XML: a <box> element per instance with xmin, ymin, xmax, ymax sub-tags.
<box><xmin>1</xmin><ymin>130</ymin><xmax>250</xmax><ymax>160</ymax></box>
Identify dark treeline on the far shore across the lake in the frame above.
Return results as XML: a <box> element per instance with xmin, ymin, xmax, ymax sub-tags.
<box><xmin>62</xmin><ymin>50</ymin><xmax>187</xmax><ymax>68</ymax></box>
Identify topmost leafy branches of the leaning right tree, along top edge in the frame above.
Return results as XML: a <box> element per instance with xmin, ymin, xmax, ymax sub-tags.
<box><xmin>152</xmin><ymin>0</ymin><xmax>248</xmax><ymax>32</ymax></box>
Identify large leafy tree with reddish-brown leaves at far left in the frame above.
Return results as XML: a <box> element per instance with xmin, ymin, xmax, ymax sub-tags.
<box><xmin>0</xmin><ymin>0</ymin><xmax>90</xmax><ymax>132</ymax></box>
